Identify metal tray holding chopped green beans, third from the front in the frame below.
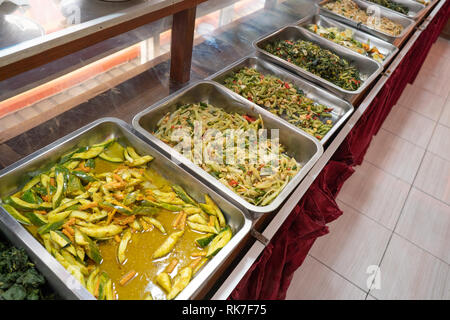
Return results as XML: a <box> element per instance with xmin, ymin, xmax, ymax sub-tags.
<box><xmin>208</xmin><ymin>56</ymin><xmax>354</xmax><ymax>144</ymax></box>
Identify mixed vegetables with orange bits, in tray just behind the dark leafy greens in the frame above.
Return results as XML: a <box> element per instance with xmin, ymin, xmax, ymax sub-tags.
<box><xmin>307</xmin><ymin>24</ymin><xmax>385</xmax><ymax>62</ymax></box>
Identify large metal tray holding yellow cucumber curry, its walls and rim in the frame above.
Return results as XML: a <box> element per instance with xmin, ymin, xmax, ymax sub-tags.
<box><xmin>0</xmin><ymin>118</ymin><xmax>251</xmax><ymax>300</ymax></box>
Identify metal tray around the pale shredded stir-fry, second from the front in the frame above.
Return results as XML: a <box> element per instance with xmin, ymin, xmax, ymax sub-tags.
<box><xmin>133</xmin><ymin>81</ymin><xmax>323</xmax><ymax>215</ymax></box>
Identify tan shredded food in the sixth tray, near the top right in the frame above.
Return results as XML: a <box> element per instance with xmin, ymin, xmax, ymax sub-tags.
<box><xmin>323</xmin><ymin>0</ymin><xmax>403</xmax><ymax>36</ymax></box>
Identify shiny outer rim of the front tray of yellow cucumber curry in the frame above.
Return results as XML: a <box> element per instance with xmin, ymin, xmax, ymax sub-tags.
<box><xmin>0</xmin><ymin>117</ymin><xmax>252</xmax><ymax>300</ymax></box>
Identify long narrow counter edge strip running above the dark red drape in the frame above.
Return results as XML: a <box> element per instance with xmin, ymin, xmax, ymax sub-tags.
<box><xmin>212</xmin><ymin>1</ymin><xmax>445</xmax><ymax>300</ymax></box>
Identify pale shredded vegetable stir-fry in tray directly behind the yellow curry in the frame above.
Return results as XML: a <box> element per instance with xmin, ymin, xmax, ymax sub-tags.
<box><xmin>153</xmin><ymin>103</ymin><xmax>300</xmax><ymax>206</ymax></box>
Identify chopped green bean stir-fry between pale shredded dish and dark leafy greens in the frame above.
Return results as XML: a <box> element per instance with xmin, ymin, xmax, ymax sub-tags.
<box><xmin>224</xmin><ymin>68</ymin><xmax>333</xmax><ymax>140</ymax></box>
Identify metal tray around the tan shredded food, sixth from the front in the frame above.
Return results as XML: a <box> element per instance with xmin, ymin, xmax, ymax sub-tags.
<box><xmin>316</xmin><ymin>0</ymin><xmax>415</xmax><ymax>43</ymax></box>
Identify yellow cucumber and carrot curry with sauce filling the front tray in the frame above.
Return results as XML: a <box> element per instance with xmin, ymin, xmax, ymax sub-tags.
<box><xmin>2</xmin><ymin>139</ymin><xmax>233</xmax><ymax>300</ymax></box>
